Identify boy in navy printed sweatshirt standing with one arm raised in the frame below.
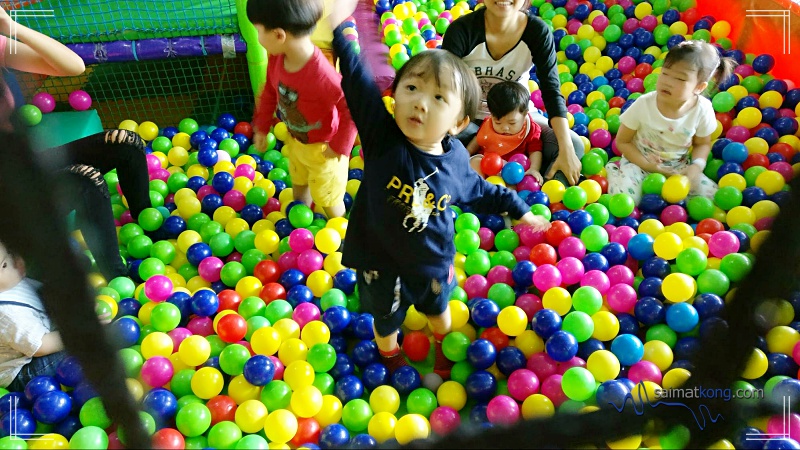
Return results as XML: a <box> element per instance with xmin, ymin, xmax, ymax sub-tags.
<box><xmin>330</xmin><ymin>0</ymin><xmax>550</xmax><ymax>379</ymax></box>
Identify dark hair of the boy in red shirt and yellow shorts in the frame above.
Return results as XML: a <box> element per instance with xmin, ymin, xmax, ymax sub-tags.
<box><xmin>247</xmin><ymin>0</ymin><xmax>324</xmax><ymax>36</ymax></box>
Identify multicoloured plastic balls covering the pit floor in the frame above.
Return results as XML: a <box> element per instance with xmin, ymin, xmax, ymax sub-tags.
<box><xmin>0</xmin><ymin>0</ymin><xmax>800</xmax><ymax>449</ymax></box>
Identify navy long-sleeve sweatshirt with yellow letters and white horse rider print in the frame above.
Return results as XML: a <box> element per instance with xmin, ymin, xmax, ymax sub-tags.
<box><xmin>333</xmin><ymin>26</ymin><xmax>529</xmax><ymax>278</ymax></box>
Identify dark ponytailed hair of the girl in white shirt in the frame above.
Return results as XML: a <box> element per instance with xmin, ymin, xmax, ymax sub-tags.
<box><xmin>664</xmin><ymin>40</ymin><xmax>736</xmax><ymax>91</ymax></box>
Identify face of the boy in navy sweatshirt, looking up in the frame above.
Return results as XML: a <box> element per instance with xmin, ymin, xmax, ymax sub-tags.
<box><xmin>394</xmin><ymin>74</ymin><xmax>469</xmax><ymax>150</ymax></box>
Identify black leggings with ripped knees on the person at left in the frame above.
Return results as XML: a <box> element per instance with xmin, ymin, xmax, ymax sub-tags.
<box><xmin>40</xmin><ymin>130</ymin><xmax>150</xmax><ymax>280</ymax></box>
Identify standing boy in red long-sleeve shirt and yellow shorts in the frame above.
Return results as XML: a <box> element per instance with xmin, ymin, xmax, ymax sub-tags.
<box><xmin>247</xmin><ymin>0</ymin><xmax>356</xmax><ymax>218</ymax></box>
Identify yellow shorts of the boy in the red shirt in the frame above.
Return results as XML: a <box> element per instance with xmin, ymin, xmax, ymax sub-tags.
<box><xmin>286</xmin><ymin>137</ymin><xmax>350</xmax><ymax>208</ymax></box>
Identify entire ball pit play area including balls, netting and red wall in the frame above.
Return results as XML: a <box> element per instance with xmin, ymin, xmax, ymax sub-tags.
<box><xmin>0</xmin><ymin>0</ymin><xmax>800</xmax><ymax>449</ymax></box>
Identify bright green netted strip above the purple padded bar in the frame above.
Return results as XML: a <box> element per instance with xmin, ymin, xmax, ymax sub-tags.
<box><xmin>7</xmin><ymin>0</ymin><xmax>239</xmax><ymax>44</ymax></box>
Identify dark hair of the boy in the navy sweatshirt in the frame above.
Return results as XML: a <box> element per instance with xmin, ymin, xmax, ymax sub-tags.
<box><xmin>392</xmin><ymin>49</ymin><xmax>481</xmax><ymax>122</ymax></box>
